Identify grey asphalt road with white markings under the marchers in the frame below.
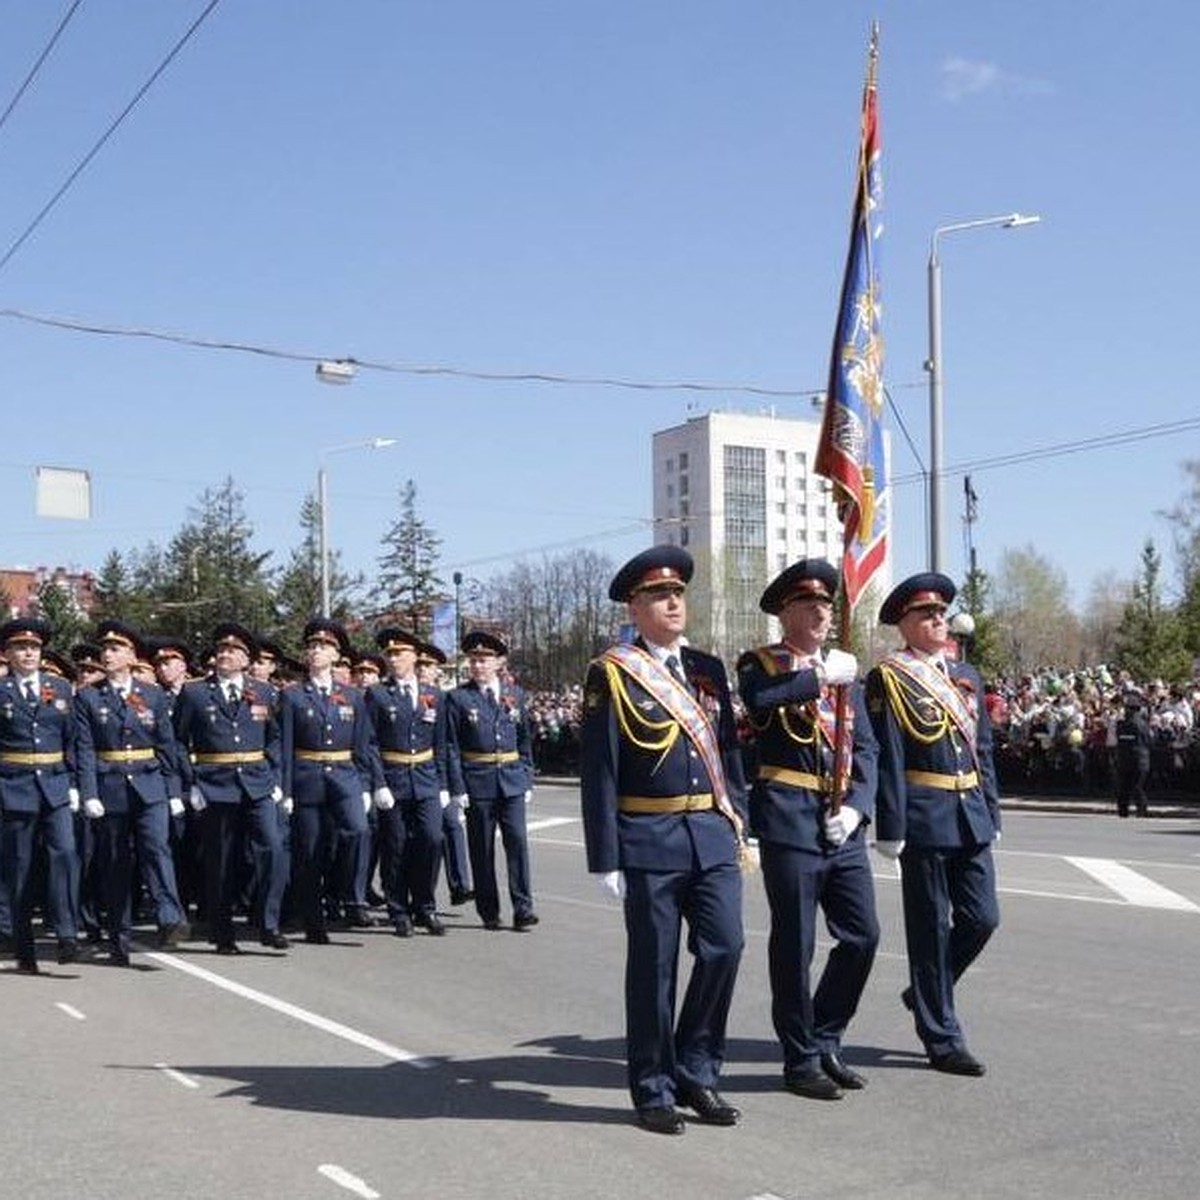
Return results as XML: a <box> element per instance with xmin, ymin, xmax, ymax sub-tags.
<box><xmin>0</xmin><ymin>786</ymin><xmax>1200</xmax><ymax>1200</ymax></box>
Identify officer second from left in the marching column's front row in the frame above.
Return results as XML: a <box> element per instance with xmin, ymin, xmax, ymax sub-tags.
<box><xmin>74</xmin><ymin>620</ymin><xmax>191</xmax><ymax>966</ymax></box>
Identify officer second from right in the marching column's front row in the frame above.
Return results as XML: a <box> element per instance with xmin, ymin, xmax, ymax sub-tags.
<box><xmin>366</xmin><ymin>629</ymin><xmax>448</xmax><ymax>937</ymax></box>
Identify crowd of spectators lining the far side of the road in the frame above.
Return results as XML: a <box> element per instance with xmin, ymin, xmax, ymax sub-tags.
<box><xmin>530</xmin><ymin>666</ymin><xmax>1200</xmax><ymax>798</ymax></box>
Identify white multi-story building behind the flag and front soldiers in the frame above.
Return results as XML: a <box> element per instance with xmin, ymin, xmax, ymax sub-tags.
<box><xmin>653</xmin><ymin>413</ymin><xmax>890</xmax><ymax>659</ymax></box>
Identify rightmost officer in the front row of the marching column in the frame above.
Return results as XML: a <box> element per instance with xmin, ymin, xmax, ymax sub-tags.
<box><xmin>445</xmin><ymin>630</ymin><xmax>538</xmax><ymax>932</ymax></box>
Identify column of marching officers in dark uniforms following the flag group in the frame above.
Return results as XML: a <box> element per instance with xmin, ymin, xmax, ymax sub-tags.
<box><xmin>0</xmin><ymin>618</ymin><xmax>538</xmax><ymax>974</ymax></box>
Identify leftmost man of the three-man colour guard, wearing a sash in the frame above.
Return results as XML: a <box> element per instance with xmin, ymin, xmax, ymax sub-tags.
<box><xmin>582</xmin><ymin>546</ymin><xmax>745</xmax><ymax>1134</ymax></box>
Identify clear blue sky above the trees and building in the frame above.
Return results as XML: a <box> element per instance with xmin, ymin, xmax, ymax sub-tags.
<box><xmin>0</xmin><ymin>0</ymin><xmax>1200</xmax><ymax>604</ymax></box>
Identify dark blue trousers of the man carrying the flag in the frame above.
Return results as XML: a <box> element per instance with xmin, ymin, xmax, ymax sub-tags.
<box><xmin>760</xmin><ymin>838</ymin><xmax>880</xmax><ymax>1075</ymax></box>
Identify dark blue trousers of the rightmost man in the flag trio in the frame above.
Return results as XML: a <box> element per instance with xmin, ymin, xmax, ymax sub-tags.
<box><xmin>900</xmin><ymin>845</ymin><xmax>1000</xmax><ymax>1056</ymax></box>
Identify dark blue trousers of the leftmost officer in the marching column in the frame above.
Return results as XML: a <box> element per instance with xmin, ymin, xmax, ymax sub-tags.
<box><xmin>0</xmin><ymin>804</ymin><xmax>79</xmax><ymax>962</ymax></box>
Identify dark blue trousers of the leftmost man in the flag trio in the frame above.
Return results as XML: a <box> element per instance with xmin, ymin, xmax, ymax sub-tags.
<box><xmin>625</xmin><ymin>863</ymin><xmax>744</xmax><ymax>1109</ymax></box>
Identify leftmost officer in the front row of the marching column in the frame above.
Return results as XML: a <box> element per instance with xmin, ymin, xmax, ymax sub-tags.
<box><xmin>0</xmin><ymin>618</ymin><xmax>79</xmax><ymax>974</ymax></box>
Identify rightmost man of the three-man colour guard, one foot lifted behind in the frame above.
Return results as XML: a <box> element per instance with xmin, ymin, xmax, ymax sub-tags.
<box><xmin>866</xmin><ymin>572</ymin><xmax>1000</xmax><ymax>1075</ymax></box>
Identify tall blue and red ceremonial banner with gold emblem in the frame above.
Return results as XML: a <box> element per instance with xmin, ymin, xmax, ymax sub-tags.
<box><xmin>815</xmin><ymin>25</ymin><xmax>892</xmax><ymax>608</ymax></box>
